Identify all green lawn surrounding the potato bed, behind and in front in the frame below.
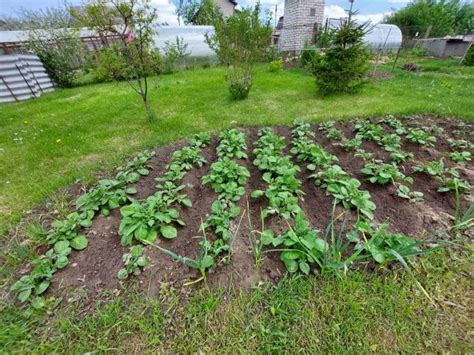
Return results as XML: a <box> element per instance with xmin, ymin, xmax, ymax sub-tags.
<box><xmin>0</xmin><ymin>59</ymin><xmax>474</xmax><ymax>353</ymax></box>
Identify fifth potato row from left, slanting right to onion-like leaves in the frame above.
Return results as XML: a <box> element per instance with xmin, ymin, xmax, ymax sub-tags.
<box><xmin>291</xmin><ymin>121</ymin><xmax>427</xmax><ymax>269</ymax></box>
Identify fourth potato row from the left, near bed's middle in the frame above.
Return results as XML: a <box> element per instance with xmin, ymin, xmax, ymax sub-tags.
<box><xmin>252</xmin><ymin>128</ymin><xmax>328</xmax><ymax>274</ymax></box>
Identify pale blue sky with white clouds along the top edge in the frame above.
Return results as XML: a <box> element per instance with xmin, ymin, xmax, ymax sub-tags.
<box><xmin>0</xmin><ymin>0</ymin><xmax>409</xmax><ymax>24</ymax></box>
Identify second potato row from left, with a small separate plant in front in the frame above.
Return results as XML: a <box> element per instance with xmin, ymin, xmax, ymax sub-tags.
<box><xmin>118</xmin><ymin>133</ymin><xmax>210</xmax><ymax>280</ymax></box>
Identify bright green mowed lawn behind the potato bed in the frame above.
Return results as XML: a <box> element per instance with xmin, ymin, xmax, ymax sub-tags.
<box><xmin>0</xmin><ymin>61</ymin><xmax>474</xmax><ymax>234</ymax></box>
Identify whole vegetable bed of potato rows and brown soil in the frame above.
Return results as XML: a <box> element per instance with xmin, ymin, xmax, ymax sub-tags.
<box><xmin>9</xmin><ymin>116</ymin><xmax>474</xmax><ymax>305</ymax></box>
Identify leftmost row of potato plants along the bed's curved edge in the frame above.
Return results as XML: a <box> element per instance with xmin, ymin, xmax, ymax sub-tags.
<box><xmin>11</xmin><ymin>151</ymin><xmax>154</xmax><ymax>307</ymax></box>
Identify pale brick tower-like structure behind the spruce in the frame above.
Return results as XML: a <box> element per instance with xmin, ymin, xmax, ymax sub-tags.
<box><xmin>278</xmin><ymin>0</ymin><xmax>325</xmax><ymax>52</ymax></box>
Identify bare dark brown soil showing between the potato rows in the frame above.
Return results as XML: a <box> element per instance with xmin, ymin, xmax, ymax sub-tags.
<box><xmin>15</xmin><ymin>117</ymin><xmax>474</xmax><ymax>301</ymax></box>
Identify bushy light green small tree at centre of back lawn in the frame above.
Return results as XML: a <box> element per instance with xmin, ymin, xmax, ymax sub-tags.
<box><xmin>206</xmin><ymin>3</ymin><xmax>272</xmax><ymax>99</ymax></box>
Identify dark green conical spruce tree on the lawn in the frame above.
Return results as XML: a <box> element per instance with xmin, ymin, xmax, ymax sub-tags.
<box><xmin>313</xmin><ymin>4</ymin><xmax>369</xmax><ymax>95</ymax></box>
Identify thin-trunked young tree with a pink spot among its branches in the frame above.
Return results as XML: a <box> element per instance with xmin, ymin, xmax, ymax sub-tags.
<box><xmin>73</xmin><ymin>0</ymin><xmax>157</xmax><ymax>122</ymax></box>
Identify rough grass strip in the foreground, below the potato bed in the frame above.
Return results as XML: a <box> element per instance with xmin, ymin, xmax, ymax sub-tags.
<box><xmin>0</xmin><ymin>252</ymin><xmax>474</xmax><ymax>354</ymax></box>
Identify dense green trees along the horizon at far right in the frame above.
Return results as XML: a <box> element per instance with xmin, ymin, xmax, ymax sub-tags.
<box><xmin>385</xmin><ymin>0</ymin><xmax>474</xmax><ymax>38</ymax></box>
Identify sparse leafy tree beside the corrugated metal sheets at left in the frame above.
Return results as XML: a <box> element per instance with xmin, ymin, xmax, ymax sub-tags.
<box><xmin>19</xmin><ymin>7</ymin><xmax>83</xmax><ymax>87</ymax></box>
